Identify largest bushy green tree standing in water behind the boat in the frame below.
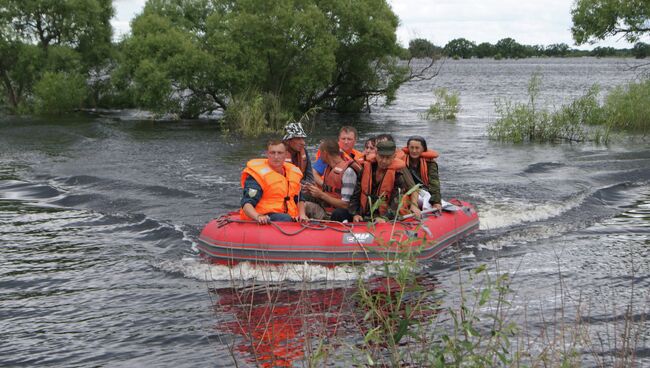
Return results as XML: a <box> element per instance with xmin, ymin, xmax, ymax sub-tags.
<box><xmin>116</xmin><ymin>0</ymin><xmax>438</xmax><ymax>117</ymax></box>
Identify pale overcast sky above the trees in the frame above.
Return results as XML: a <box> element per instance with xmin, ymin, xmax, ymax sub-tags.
<box><xmin>112</xmin><ymin>0</ymin><xmax>631</xmax><ymax>49</ymax></box>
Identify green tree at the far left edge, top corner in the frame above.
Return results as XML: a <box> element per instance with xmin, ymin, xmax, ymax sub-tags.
<box><xmin>0</xmin><ymin>0</ymin><xmax>113</xmax><ymax>112</ymax></box>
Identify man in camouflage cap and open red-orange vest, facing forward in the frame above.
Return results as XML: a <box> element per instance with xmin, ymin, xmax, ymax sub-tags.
<box><xmin>350</xmin><ymin>140</ymin><xmax>421</xmax><ymax>222</ymax></box>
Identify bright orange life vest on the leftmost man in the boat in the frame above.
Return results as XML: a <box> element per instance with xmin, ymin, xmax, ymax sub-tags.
<box><xmin>239</xmin><ymin>158</ymin><xmax>302</xmax><ymax>220</ymax></box>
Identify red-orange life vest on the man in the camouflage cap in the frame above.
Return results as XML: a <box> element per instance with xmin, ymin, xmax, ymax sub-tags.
<box><xmin>360</xmin><ymin>155</ymin><xmax>406</xmax><ymax>216</ymax></box>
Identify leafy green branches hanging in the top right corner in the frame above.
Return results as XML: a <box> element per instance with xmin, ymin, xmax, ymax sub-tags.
<box><xmin>571</xmin><ymin>0</ymin><xmax>650</xmax><ymax>45</ymax></box>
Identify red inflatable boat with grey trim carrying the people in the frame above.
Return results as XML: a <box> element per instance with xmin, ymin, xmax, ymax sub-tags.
<box><xmin>198</xmin><ymin>201</ymin><xmax>478</xmax><ymax>265</ymax></box>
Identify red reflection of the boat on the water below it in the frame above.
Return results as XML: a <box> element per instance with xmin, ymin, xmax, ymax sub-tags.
<box><xmin>210</xmin><ymin>284</ymin><xmax>354</xmax><ymax>367</ymax></box>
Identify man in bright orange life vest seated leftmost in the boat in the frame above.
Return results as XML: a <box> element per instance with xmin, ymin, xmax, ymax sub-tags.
<box><xmin>239</xmin><ymin>139</ymin><xmax>308</xmax><ymax>224</ymax></box>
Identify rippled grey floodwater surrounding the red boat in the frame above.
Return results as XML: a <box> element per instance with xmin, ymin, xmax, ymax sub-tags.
<box><xmin>0</xmin><ymin>58</ymin><xmax>650</xmax><ymax>368</ymax></box>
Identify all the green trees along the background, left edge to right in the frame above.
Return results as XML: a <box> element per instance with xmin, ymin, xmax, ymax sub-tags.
<box><xmin>0</xmin><ymin>0</ymin><xmax>650</xmax><ymax>119</ymax></box>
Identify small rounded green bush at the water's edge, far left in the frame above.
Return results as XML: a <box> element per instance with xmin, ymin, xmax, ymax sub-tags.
<box><xmin>34</xmin><ymin>71</ymin><xmax>87</xmax><ymax>115</ymax></box>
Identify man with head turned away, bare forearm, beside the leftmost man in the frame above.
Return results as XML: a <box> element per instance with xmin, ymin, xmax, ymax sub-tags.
<box><xmin>305</xmin><ymin>139</ymin><xmax>361</xmax><ymax>222</ymax></box>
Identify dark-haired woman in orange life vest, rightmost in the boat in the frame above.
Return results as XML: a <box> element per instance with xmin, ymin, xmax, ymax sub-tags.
<box><xmin>402</xmin><ymin>135</ymin><xmax>442</xmax><ymax>210</ymax></box>
